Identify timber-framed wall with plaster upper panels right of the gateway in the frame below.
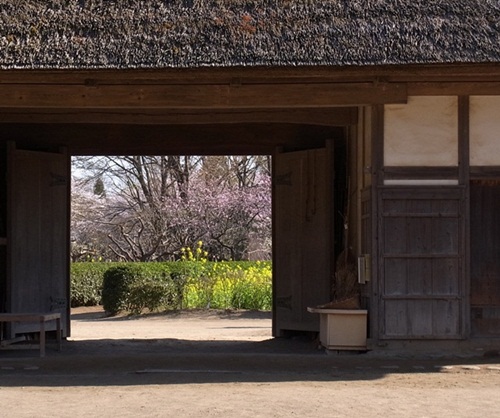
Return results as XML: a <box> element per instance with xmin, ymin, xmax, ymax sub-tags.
<box><xmin>372</xmin><ymin>94</ymin><xmax>500</xmax><ymax>339</ymax></box>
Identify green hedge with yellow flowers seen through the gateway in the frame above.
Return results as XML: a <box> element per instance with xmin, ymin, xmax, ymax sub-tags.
<box><xmin>71</xmin><ymin>260</ymin><xmax>272</xmax><ymax>313</ymax></box>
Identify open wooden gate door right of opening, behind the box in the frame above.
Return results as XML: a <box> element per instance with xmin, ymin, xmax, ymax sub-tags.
<box><xmin>273</xmin><ymin>148</ymin><xmax>333</xmax><ymax>336</ymax></box>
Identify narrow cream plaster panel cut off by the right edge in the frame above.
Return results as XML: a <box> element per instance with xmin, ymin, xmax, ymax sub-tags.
<box><xmin>470</xmin><ymin>96</ymin><xmax>500</xmax><ymax>166</ymax></box>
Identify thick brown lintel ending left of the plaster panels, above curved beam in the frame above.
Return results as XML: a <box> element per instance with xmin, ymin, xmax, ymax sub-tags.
<box><xmin>0</xmin><ymin>83</ymin><xmax>407</xmax><ymax>109</ymax></box>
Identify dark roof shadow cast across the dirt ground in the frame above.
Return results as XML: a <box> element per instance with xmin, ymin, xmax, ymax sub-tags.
<box><xmin>0</xmin><ymin>311</ymin><xmax>500</xmax><ymax>387</ymax></box>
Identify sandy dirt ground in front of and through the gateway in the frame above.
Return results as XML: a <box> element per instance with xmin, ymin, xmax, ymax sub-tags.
<box><xmin>0</xmin><ymin>308</ymin><xmax>500</xmax><ymax>418</ymax></box>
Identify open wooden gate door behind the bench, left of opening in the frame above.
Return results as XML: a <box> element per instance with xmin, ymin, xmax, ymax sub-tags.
<box><xmin>6</xmin><ymin>146</ymin><xmax>70</xmax><ymax>337</ymax></box>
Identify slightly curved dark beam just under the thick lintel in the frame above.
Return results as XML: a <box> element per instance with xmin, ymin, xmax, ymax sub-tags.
<box><xmin>0</xmin><ymin>107</ymin><xmax>358</xmax><ymax>126</ymax></box>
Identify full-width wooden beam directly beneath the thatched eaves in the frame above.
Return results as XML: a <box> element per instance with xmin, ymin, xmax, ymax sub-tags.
<box><xmin>0</xmin><ymin>63</ymin><xmax>500</xmax><ymax>85</ymax></box>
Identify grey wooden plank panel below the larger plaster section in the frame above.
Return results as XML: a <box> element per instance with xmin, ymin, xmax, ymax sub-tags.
<box><xmin>379</xmin><ymin>188</ymin><xmax>464</xmax><ymax>339</ymax></box>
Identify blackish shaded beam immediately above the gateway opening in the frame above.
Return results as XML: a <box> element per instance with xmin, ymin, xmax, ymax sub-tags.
<box><xmin>0</xmin><ymin>123</ymin><xmax>344</xmax><ymax>155</ymax></box>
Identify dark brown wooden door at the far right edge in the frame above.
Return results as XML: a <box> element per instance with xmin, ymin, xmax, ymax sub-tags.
<box><xmin>470</xmin><ymin>180</ymin><xmax>500</xmax><ymax>337</ymax></box>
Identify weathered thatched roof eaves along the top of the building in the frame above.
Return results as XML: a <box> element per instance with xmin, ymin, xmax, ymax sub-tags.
<box><xmin>0</xmin><ymin>0</ymin><xmax>500</xmax><ymax>69</ymax></box>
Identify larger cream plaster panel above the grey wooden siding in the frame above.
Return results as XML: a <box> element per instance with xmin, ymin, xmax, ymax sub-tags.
<box><xmin>384</xmin><ymin>96</ymin><xmax>458</xmax><ymax>167</ymax></box>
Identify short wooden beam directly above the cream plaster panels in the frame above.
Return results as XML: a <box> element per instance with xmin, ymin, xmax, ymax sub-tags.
<box><xmin>408</xmin><ymin>81</ymin><xmax>500</xmax><ymax>96</ymax></box>
